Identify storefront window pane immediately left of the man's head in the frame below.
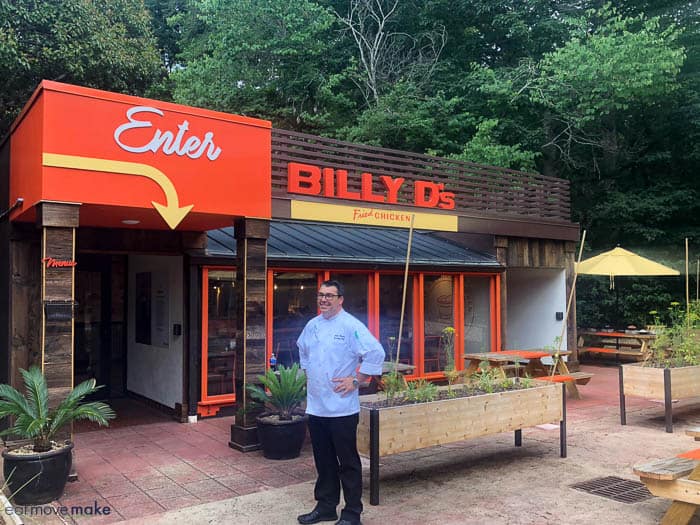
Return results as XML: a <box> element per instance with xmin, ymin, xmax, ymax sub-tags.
<box><xmin>272</xmin><ymin>272</ymin><xmax>318</xmax><ymax>366</ymax></box>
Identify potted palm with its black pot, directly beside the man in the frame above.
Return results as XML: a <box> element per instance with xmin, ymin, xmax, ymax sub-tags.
<box><xmin>246</xmin><ymin>363</ymin><xmax>308</xmax><ymax>459</ymax></box>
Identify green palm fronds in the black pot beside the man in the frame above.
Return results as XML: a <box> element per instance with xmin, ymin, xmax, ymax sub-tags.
<box><xmin>246</xmin><ymin>363</ymin><xmax>306</xmax><ymax>420</ymax></box>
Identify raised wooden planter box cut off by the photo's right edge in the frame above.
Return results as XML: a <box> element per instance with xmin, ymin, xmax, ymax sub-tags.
<box><xmin>620</xmin><ymin>363</ymin><xmax>700</xmax><ymax>432</ymax></box>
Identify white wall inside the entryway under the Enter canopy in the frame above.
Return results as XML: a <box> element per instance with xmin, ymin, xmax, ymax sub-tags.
<box><xmin>126</xmin><ymin>255</ymin><xmax>183</xmax><ymax>408</ymax></box>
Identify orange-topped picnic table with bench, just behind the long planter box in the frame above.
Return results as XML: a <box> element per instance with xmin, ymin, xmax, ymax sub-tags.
<box><xmin>464</xmin><ymin>350</ymin><xmax>593</xmax><ymax>399</ymax></box>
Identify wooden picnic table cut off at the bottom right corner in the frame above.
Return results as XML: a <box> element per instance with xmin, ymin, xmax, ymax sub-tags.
<box><xmin>634</xmin><ymin>428</ymin><xmax>700</xmax><ymax>525</ymax></box>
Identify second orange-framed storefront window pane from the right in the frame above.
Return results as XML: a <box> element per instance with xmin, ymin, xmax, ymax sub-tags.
<box><xmin>423</xmin><ymin>275</ymin><xmax>456</xmax><ymax>373</ymax></box>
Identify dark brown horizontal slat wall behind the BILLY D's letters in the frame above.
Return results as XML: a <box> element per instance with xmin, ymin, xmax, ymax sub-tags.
<box><xmin>272</xmin><ymin>129</ymin><xmax>571</xmax><ymax>222</ymax></box>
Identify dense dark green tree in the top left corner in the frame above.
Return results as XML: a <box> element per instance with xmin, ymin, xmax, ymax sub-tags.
<box><xmin>0</xmin><ymin>0</ymin><xmax>162</xmax><ymax>135</ymax></box>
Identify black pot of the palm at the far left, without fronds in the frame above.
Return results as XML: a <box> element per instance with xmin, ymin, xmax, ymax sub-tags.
<box><xmin>2</xmin><ymin>443</ymin><xmax>73</xmax><ymax>505</ymax></box>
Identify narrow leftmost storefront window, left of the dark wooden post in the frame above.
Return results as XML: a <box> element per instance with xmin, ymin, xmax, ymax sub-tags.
<box><xmin>206</xmin><ymin>270</ymin><xmax>236</xmax><ymax>396</ymax></box>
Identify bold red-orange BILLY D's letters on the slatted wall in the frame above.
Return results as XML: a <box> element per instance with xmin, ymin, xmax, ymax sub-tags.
<box><xmin>287</xmin><ymin>162</ymin><xmax>455</xmax><ymax>210</ymax></box>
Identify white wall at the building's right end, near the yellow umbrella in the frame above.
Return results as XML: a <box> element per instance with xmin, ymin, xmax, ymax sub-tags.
<box><xmin>506</xmin><ymin>268</ymin><xmax>567</xmax><ymax>350</ymax></box>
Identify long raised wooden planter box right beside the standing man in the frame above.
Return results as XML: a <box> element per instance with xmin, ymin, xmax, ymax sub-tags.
<box><xmin>357</xmin><ymin>381</ymin><xmax>566</xmax><ymax>505</ymax></box>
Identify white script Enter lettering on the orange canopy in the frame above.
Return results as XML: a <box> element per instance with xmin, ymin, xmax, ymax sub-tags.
<box><xmin>114</xmin><ymin>106</ymin><xmax>221</xmax><ymax>160</ymax></box>
